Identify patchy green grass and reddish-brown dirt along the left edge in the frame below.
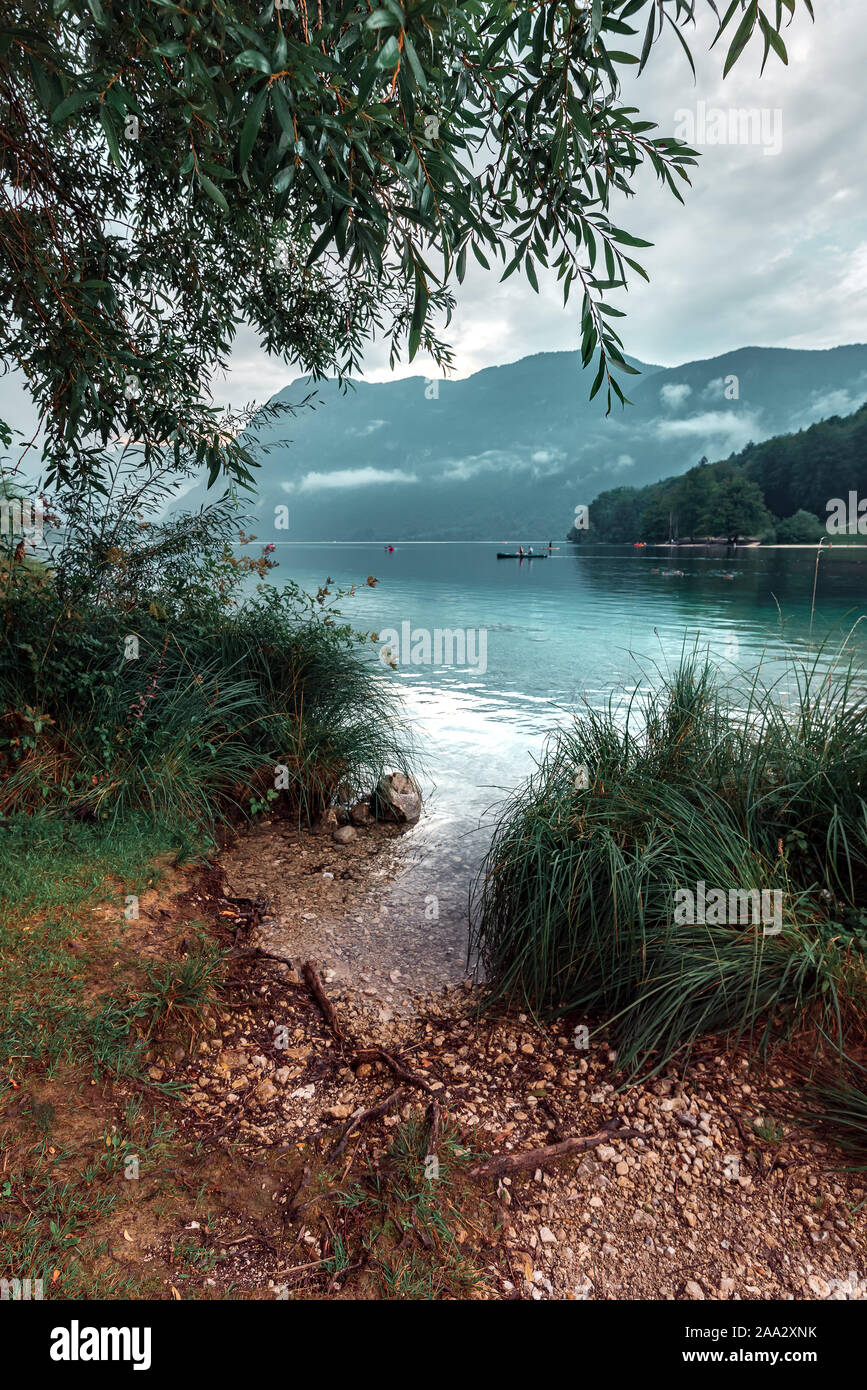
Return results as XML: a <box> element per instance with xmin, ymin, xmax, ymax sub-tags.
<box><xmin>0</xmin><ymin>813</ymin><xmax>234</xmax><ymax>1300</ymax></box>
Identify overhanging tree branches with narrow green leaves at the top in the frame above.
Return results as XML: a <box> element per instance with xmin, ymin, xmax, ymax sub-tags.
<box><xmin>0</xmin><ymin>0</ymin><xmax>813</xmax><ymax>487</ymax></box>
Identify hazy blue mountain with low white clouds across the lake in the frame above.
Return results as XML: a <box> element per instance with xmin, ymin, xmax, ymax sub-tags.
<box><xmin>183</xmin><ymin>345</ymin><xmax>867</xmax><ymax>541</ymax></box>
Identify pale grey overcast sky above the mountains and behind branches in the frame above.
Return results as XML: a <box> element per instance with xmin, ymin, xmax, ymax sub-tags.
<box><xmin>0</xmin><ymin>0</ymin><xmax>867</xmax><ymax>424</ymax></box>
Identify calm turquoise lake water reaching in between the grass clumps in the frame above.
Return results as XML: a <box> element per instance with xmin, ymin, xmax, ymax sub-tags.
<box><xmin>263</xmin><ymin>539</ymin><xmax>867</xmax><ymax>984</ymax></box>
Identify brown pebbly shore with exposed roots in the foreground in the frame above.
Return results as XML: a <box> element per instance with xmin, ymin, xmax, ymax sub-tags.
<box><xmin>128</xmin><ymin>806</ymin><xmax>867</xmax><ymax>1300</ymax></box>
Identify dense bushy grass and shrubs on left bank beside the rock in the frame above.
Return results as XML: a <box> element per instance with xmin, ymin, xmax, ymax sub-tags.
<box><xmin>0</xmin><ymin>480</ymin><xmax>408</xmax><ymax>826</ymax></box>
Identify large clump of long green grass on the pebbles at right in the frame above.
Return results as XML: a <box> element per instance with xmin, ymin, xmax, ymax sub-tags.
<box><xmin>474</xmin><ymin>652</ymin><xmax>867</xmax><ymax>1069</ymax></box>
